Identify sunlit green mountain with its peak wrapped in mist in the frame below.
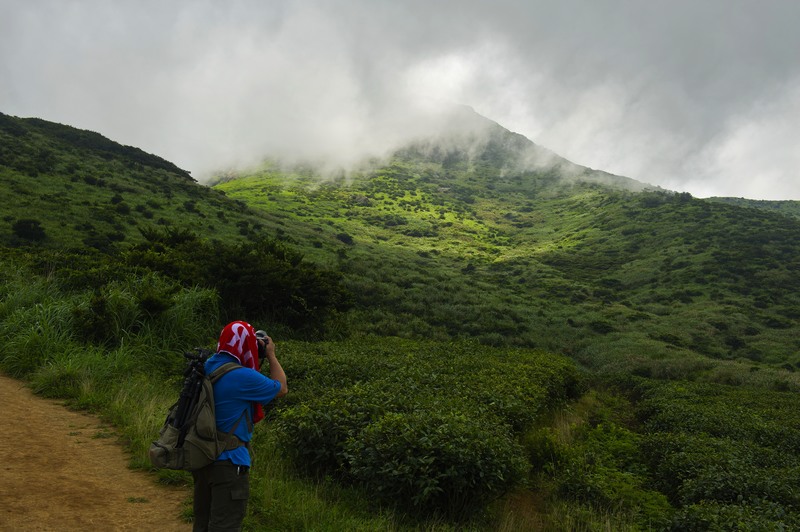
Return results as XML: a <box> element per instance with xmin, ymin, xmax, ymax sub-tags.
<box><xmin>216</xmin><ymin>108</ymin><xmax>800</xmax><ymax>374</ymax></box>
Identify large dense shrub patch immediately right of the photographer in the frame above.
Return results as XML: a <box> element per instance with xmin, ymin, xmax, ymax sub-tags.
<box><xmin>276</xmin><ymin>340</ymin><xmax>579</xmax><ymax>516</ymax></box>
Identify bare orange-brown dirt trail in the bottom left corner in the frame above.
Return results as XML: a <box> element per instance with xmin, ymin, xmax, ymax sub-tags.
<box><xmin>0</xmin><ymin>375</ymin><xmax>191</xmax><ymax>531</ymax></box>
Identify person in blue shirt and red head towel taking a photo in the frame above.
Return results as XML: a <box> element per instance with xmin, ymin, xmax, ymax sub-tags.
<box><xmin>192</xmin><ymin>321</ymin><xmax>289</xmax><ymax>531</ymax></box>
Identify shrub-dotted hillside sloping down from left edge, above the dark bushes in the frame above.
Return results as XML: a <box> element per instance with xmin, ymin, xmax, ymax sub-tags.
<box><xmin>0</xmin><ymin>113</ymin><xmax>270</xmax><ymax>251</ymax></box>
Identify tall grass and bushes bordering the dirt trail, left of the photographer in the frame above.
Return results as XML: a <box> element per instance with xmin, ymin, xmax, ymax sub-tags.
<box><xmin>0</xmin><ymin>272</ymin><xmax>218</xmax><ymax>450</ymax></box>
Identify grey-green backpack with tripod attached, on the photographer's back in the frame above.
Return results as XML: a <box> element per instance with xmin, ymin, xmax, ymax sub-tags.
<box><xmin>150</xmin><ymin>353</ymin><xmax>249</xmax><ymax>471</ymax></box>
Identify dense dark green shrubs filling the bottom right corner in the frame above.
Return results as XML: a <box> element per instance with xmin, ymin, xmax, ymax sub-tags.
<box><xmin>639</xmin><ymin>383</ymin><xmax>800</xmax><ymax>529</ymax></box>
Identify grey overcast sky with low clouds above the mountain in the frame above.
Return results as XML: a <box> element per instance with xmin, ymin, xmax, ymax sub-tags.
<box><xmin>0</xmin><ymin>0</ymin><xmax>800</xmax><ymax>200</ymax></box>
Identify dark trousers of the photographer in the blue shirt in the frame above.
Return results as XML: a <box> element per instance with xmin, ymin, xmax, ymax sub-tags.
<box><xmin>192</xmin><ymin>460</ymin><xmax>250</xmax><ymax>532</ymax></box>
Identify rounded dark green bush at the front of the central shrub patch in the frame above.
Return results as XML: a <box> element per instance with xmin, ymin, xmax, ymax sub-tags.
<box><xmin>344</xmin><ymin>412</ymin><xmax>526</xmax><ymax>517</ymax></box>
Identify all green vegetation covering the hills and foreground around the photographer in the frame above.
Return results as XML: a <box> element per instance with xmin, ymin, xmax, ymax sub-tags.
<box><xmin>0</xmin><ymin>110</ymin><xmax>800</xmax><ymax>530</ymax></box>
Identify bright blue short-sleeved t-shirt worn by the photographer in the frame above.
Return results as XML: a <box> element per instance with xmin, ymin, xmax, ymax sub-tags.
<box><xmin>205</xmin><ymin>352</ymin><xmax>281</xmax><ymax>466</ymax></box>
